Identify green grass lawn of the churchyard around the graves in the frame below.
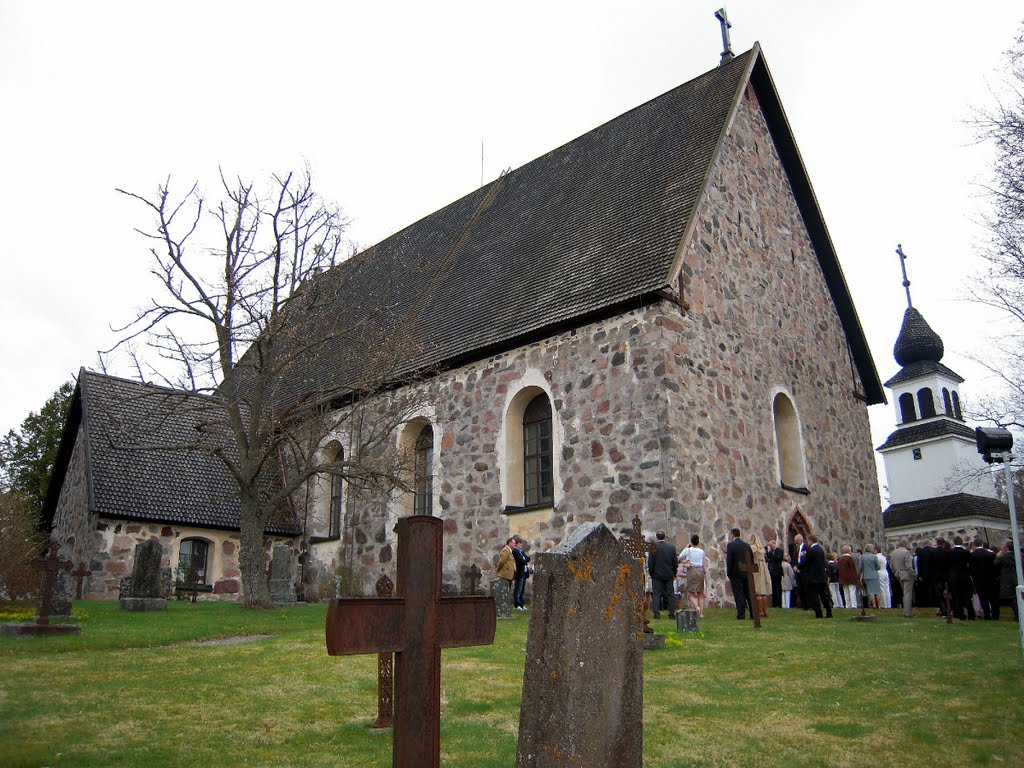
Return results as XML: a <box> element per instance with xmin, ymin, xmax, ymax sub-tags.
<box><xmin>0</xmin><ymin>602</ymin><xmax>1024</xmax><ymax>768</ymax></box>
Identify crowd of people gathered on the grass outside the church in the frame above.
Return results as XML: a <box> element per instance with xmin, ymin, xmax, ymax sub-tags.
<box><xmin>498</xmin><ymin>528</ymin><xmax>1018</xmax><ymax>621</ymax></box>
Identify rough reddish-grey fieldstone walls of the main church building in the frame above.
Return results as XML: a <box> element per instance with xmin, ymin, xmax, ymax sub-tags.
<box><xmin>323</xmin><ymin>81</ymin><xmax>882</xmax><ymax>602</ymax></box>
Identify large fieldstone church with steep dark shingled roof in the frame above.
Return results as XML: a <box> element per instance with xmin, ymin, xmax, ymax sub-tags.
<box><xmin>48</xmin><ymin>46</ymin><xmax>885</xmax><ymax>602</ymax></box>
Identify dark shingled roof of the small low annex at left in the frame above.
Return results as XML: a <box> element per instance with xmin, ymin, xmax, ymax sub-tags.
<box><xmin>45</xmin><ymin>369</ymin><xmax>298</xmax><ymax>535</ymax></box>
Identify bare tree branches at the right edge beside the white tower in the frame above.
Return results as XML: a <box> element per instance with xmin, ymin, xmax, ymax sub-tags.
<box><xmin>968</xmin><ymin>30</ymin><xmax>1024</xmax><ymax>429</ymax></box>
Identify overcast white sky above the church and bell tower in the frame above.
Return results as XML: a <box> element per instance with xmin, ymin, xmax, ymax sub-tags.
<box><xmin>0</xmin><ymin>0</ymin><xmax>1024</xmax><ymax>501</ymax></box>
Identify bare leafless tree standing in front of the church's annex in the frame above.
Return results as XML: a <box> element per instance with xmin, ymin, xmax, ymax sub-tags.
<box><xmin>118</xmin><ymin>169</ymin><xmax>425</xmax><ymax>606</ymax></box>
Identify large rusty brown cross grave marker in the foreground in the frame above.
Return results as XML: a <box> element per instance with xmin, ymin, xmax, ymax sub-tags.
<box><xmin>327</xmin><ymin>515</ymin><xmax>497</xmax><ymax>768</ymax></box>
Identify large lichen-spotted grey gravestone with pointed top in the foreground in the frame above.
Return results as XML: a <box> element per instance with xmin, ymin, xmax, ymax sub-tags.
<box><xmin>516</xmin><ymin>523</ymin><xmax>644</xmax><ymax>768</ymax></box>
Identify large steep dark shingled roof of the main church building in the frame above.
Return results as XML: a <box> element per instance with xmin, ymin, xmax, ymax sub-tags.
<box><xmin>268</xmin><ymin>46</ymin><xmax>885</xmax><ymax>404</ymax></box>
